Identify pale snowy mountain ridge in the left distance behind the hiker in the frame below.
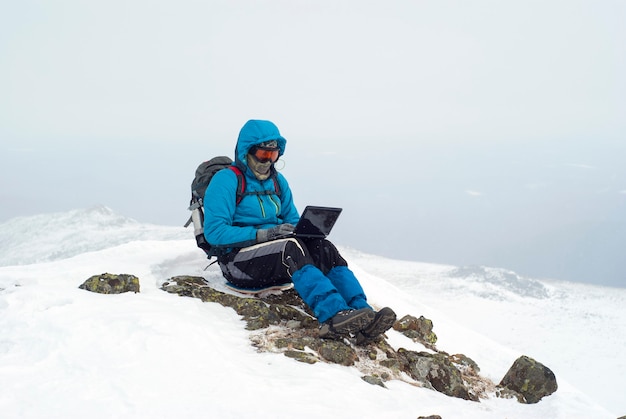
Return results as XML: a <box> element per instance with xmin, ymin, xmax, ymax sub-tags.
<box><xmin>0</xmin><ymin>206</ymin><xmax>186</xmax><ymax>266</ymax></box>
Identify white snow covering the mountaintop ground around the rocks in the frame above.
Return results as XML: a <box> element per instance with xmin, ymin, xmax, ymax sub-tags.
<box><xmin>0</xmin><ymin>208</ymin><xmax>626</xmax><ymax>419</ymax></box>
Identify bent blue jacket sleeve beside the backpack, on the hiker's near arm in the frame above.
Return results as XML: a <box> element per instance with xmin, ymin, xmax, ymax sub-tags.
<box><xmin>204</xmin><ymin>170</ymin><xmax>256</xmax><ymax>247</ymax></box>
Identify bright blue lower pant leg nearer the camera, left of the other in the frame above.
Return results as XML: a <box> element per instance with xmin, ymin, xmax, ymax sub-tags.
<box><xmin>291</xmin><ymin>265</ymin><xmax>350</xmax><ymax>323</ymax></box>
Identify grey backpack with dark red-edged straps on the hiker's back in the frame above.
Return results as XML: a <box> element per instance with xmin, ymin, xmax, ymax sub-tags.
<box><xmin>185</xmin><ymin>156</ymin><xmax>280</xmax><ymax>259</ymax></box>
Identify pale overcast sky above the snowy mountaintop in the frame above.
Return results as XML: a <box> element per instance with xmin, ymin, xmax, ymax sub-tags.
<box><xmin>0</xmin><ymin>0</ymin><xmax>626</xmax><ymax>286</ymax></box>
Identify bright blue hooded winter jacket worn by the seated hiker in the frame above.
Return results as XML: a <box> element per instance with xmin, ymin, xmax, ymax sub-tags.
<box><xmin>204</xmin><ymin>120</ymin><xmax>300</xmax><ymax>248</ymax></box>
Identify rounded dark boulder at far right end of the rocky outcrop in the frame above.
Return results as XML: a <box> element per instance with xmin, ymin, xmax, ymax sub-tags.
<box><xmin>498</xmin><ymin>356</ymin><xmax>558</xmax><ymax>404</ymax></box>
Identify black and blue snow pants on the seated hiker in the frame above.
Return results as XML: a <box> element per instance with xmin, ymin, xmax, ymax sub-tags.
<box><xmin>218</xmin><ymin>238</ymin><xmax>371</xmax><ymax>323</ymax></box>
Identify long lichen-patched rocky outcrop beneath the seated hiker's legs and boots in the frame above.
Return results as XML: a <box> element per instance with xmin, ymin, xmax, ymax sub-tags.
<box><xmin>162</xmin><ymin>276</ymin><xmax>552</xmax><ymax>401</ymax></box>
